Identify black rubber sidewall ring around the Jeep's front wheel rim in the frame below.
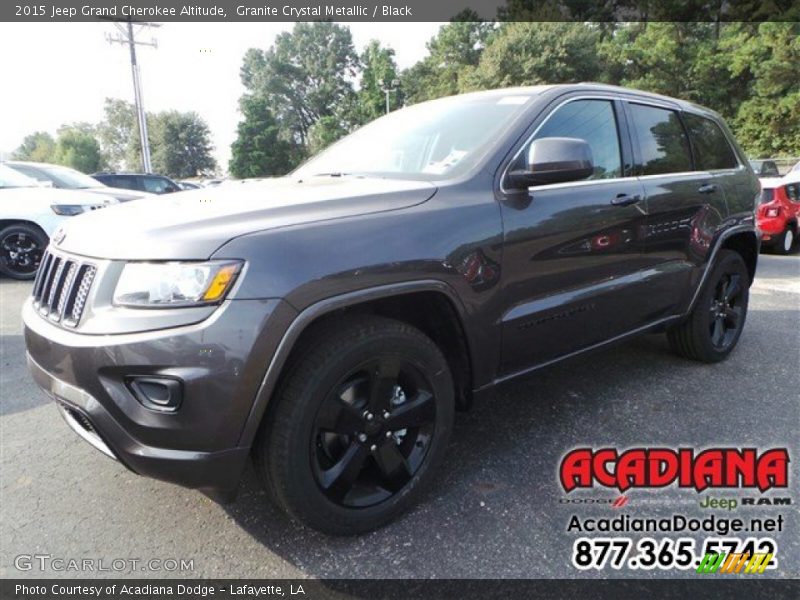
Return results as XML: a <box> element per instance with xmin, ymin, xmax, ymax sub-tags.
<box><xmin>276</xmin><ymin>332</ymin><xmax>455</xmax><ymax>532</ymax></box>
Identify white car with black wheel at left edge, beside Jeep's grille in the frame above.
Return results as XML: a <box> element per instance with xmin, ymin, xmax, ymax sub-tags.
<box><xmin>0</xmin><ymin>164</ymin><xmax>118</xmax><ymax>279</ymax></box>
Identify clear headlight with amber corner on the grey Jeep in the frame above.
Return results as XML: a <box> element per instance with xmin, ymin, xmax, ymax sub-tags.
<box><xmin>114</xmin><ymin>261</ymin><xmax>242</xmax><ymax>308</ymax></box>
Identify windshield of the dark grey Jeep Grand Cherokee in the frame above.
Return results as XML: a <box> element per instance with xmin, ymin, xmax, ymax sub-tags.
<box><xmin>294</xmin><ymin>92</ymin><xmax>533</xmax><ymax>179</ymax></box>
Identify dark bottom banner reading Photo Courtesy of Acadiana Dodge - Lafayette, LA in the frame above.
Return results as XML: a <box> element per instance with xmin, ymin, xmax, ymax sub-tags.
<box><xmin>0</xmin><ymin>575</ymin><xmax>800</xmax><ymax>600</ymax></box>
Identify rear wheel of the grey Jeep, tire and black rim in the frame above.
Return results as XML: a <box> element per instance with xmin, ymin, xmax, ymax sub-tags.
<box><xmin>667</xmin><ymin>250</ymin><xmax>750</xmax><ymax>363</ymax></box>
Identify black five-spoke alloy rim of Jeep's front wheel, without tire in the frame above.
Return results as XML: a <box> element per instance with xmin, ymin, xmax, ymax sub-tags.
<box><xmin>311</xmin><ymin>356</ymin><xmax>436</xmax><ymax>508</ymax></box>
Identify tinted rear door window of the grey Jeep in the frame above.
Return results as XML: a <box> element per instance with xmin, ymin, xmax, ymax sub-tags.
<box><xmin>630</xmin><ymin>104</ymin><xmax>692</xmax><ymax>175</ymax></box>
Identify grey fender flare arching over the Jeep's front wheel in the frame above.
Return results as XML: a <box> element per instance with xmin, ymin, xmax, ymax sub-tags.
<box><xmin>239</xmin><ymin>279</ymin><xmax>466</xmax><ymax>447</ymax></box>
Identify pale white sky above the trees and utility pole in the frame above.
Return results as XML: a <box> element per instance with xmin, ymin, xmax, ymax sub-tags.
<box><xmin>0</xmin><ymin>23</ymin><xmax>441</xmax><ymax>169</ymax></box>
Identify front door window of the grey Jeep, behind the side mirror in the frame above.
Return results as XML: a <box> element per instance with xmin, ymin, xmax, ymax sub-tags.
<box><xmin>535</xmin><ymin>100</ymin><xmax>622</xmax><ymax>179</ymax></box>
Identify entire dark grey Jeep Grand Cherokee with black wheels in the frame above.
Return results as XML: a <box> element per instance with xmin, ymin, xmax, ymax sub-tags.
<box><xmin>24</xmin><ymin>84</ymin><xmax>759</xmax><ymax>534</ymax></box>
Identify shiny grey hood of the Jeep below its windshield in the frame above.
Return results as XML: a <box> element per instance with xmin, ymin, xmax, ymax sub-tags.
<box><xmin>54</xmin><ymin>176</ymin><xmax>436</xmax><ymax>260</ymax></box>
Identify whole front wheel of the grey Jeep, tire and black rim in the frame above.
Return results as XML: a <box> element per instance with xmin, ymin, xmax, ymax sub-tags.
<box><xmin>253</xmin><ymin>315</ymin><xmax>455</xmax><ymax>535</ymax></box>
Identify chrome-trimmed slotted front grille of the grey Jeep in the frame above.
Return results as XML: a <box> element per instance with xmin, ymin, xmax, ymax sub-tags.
<box><xmin>33</xmin><ymin>251</ymin><xmax>97</xmax><ymax>327</ymax></box>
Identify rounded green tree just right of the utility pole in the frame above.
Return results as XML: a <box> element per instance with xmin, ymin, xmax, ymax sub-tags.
<box><xmin>148</xmin><ymin>110</ymin><xmax>216</xmax><ymax>178</ymax></box>
